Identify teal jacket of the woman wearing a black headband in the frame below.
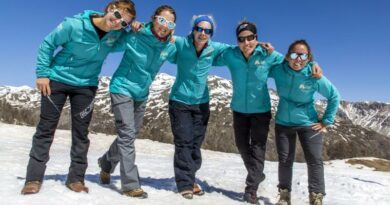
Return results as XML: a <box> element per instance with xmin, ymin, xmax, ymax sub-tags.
<box><xmin>216</xmin><ymin>46</ymin><xmax>283</xmax><ymax>113</ymax></box>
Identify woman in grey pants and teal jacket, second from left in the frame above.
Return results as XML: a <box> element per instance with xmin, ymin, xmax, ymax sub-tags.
<box><xmin>98</xmin><ymin>5</ymin><xmax>176</xmax><ymax>198</ymax></box>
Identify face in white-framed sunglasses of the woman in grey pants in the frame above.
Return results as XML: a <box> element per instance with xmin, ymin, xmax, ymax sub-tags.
<box><xmin>152</xmin><ymin>10</ymin><xmax>175</xmax><ymax>38</ymax></box>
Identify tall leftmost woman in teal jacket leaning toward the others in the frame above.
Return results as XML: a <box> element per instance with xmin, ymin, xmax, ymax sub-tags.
<box><xmin>21</xmin><ymin>0</ymin><xmax>136</xmax><ymax>194</ymax></box>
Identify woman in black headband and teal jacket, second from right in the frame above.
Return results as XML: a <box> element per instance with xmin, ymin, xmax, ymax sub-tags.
<box><xmin>216</xmin><ymin>21</ymin><xmax>320</xmax><ymax>204</ymax></box>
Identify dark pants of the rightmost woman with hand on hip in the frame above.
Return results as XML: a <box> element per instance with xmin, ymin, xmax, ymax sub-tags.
<box><xmin>275</xmin><ymin>124</ymin><xmax>325</xmax><ymax>194</ymax></box>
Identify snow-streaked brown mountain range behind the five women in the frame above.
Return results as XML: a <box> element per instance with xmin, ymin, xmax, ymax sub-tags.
<box><xmin>0</xmin><ymin>73</ymin><xmax>390</xmax><ymax>161</ymax></box>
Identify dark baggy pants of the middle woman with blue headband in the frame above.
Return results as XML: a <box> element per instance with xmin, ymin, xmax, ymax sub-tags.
<box><xmin>169</xmin><ymin>101</ymin><xmax>210</xmax><ymax>192</ymax></box>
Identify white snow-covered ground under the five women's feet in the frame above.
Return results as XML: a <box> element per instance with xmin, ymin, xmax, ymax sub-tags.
<box><xmin>0</xmin><ymin>123</ymin><xmax>390</xmax><ymax>205</ymax></box>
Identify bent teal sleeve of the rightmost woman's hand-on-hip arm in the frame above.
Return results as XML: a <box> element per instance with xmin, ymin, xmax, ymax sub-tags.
<box><xmin>317</xmin><ymin>76</ymin><xmax>340</xmax><ymax>125</ymax></box>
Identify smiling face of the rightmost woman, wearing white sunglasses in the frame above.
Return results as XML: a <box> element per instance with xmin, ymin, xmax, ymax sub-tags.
<box><xmin>287</xmin><ymin>44</ymin><xmax>309</xmax><ymax>71</ymax></box>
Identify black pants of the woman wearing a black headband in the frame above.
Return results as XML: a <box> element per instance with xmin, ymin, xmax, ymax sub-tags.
<box><xmin>233</xmin><ymin>111</ymin><xmax>271</xmax><ymax>192</ymax></box>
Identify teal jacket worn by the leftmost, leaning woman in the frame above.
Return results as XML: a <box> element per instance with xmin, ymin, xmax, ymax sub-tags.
<box><xmin>36</xmin><ymin>11</ymin><xmax>125</xmax><ymax>86</ymax></box>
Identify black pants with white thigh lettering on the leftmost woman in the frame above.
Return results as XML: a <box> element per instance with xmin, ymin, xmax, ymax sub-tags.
<box><xmin>26</xmin><ymin>81</ymin><xmax>97</xmax><ymax>183</ymax></box>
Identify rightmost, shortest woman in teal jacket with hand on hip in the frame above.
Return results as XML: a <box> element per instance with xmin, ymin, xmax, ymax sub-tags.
<box><xmin>270</xmin><ymin>40</ymin><xmax>340</xmax><ymax>205</ymax></box>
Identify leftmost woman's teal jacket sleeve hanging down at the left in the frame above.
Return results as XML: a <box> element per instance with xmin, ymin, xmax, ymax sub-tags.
<box><xmin>36</xmin><ymin>19</ymin><xmax>75</xmax><ymax>78</ymax></box>
